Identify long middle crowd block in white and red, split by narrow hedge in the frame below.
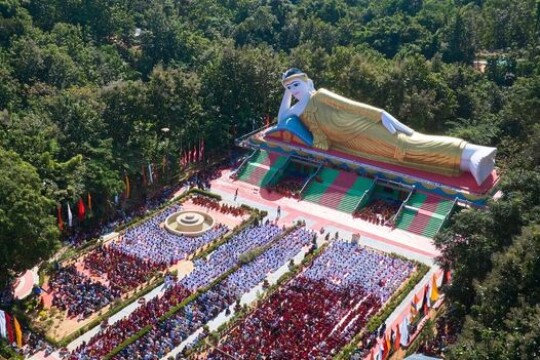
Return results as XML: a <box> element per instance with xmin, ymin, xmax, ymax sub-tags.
<box><xmin>71</xmin><ymin>223</ymin><xmax>286</xmax><ymax>360</ymax></box>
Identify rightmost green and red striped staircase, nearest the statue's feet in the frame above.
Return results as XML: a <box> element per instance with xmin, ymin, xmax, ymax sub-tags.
<box><xmin>396</xmin><ymin>192</ymin><xmax>454</xmax><ymax>238</ymax></box>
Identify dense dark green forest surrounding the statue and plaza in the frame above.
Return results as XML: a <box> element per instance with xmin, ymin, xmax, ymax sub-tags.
<box><xmin>0</xmin><ymin>0</ymin><xmax>540</xmax><ymax>359</ymax></box>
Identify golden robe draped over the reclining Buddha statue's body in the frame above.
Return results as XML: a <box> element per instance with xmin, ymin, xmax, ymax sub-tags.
<box><xmin>300</xmin><ymin>89</ymin><xmax>467</xmax><ymax>176</ymax></box>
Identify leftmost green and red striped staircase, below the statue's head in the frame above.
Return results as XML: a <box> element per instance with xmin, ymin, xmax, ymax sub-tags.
<box><xmin>238</xmin><ymin>150</ymin><xmax>287</xmax><ymax>187</ymax></box>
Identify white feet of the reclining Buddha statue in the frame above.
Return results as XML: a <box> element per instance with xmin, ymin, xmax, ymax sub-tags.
<box><xmin>461</xmin><ymin>144</ymin><xmax>497</xmax><ymax>185</ymax></box>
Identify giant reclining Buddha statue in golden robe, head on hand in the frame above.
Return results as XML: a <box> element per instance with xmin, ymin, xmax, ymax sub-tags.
<box><xmin>278</xmin><ymin>68</ymin><xmax>497</xmax><ymax>185</ymax></box>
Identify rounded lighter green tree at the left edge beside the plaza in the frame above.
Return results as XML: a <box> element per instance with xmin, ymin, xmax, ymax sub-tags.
<box><xmin>0</xmin><ymin>147</ymin><xmax>59</xmax><ymax>288</ymax></box>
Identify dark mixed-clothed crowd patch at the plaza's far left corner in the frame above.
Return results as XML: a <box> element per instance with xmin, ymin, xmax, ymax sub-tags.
<box><xmin>49</xmin><ymin>265</ymin><xmax>122</xmax><ymax>318</ymax></box>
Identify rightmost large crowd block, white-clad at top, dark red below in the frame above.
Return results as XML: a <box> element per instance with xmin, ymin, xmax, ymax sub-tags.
<box><xmin>208</xmin><ymin>241</ymin><xmax>414</xmax><ymax>359</ymax></box>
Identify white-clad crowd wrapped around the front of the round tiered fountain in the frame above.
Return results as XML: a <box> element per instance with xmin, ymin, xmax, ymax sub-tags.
<box><xmin>115</xmin><ymin>205</ymin><xmax>229</xmax><ymax>265</ymax></box>
